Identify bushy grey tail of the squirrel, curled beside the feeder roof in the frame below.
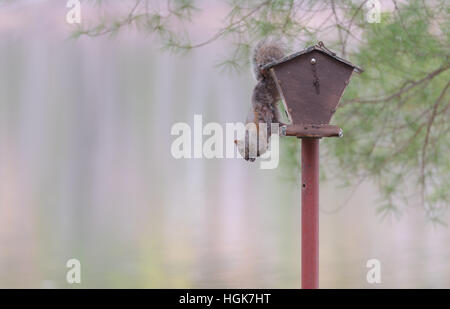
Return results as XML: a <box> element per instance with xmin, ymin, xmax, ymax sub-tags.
<box><xmin>252</xmin><ymin>39</ymin><xmax>284</xmax><ymax>80</ymax></box>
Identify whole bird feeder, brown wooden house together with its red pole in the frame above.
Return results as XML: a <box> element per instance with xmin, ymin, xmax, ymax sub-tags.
<box><xmin>261</xmin><ymin>42</ymin><xmax>363</xmax><ymax>289</ymax></box>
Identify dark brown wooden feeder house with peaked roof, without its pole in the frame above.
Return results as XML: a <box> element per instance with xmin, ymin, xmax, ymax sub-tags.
<box><xmin>261</xmin><ymin>42</ymin><xmax>363</xmax><ymax>138</ymax></box>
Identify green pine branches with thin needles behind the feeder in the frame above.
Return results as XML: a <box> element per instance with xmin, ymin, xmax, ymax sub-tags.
<box><xmin>68</xmin><ymin>0</ymin><xmax>450</xmax><ymax>223</ymax></box>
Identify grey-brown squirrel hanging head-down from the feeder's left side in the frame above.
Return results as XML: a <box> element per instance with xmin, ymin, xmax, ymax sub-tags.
<box><xmin>234</xmin><ymin>40</ymin><xmax>285</xmax><ymax>162</ymax></box>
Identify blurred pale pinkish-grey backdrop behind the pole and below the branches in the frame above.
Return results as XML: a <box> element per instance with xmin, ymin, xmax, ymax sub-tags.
<box><xmin>0</xmin><ymin>1</ymin><xmax>450</xmax><ymax>288</ymax></box>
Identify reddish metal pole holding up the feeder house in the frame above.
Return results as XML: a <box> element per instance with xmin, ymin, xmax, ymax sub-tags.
<box><xmin>302</xmin><ymin>138</ymin><xmax>319</xmax><ymax>289</ymax></box>
